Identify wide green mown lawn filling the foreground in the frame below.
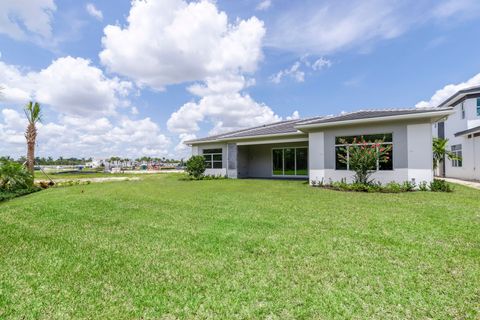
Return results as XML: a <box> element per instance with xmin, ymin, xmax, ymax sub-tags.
<box><xmin>0</xmin><ymin>175</ymin><xmax>480</xmax><ymax>319</ymax></box>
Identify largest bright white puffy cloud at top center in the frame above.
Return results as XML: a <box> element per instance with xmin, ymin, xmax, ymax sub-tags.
<box><xmin>100</xmin><ymin>0</ymin><xmax>265</xmax><ymax>90</ymax></box>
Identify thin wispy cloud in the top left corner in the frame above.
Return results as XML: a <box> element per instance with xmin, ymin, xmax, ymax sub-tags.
<box><xmin>0</xmin><ymin>0</ymin><xmax>56</xmax><ymax>40</ymax></box>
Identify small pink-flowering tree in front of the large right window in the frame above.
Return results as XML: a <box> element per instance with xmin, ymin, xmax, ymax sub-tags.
<box><xmin>338</xmin><ymin>137</ymin><xmax>392</xmax><ymax>184</ymax></box>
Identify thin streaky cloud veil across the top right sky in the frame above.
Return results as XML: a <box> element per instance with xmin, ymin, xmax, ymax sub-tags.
<box><xmin>267</xmin><ymin>0</ymin><xmax>480</xmax><ymax>54</ymax></box>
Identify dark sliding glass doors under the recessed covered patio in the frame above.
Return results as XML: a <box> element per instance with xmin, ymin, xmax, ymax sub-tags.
<box><xmin>272</xmin><ymin>147</ymin><xmax>308</xmax><ymax>176</ymax></box>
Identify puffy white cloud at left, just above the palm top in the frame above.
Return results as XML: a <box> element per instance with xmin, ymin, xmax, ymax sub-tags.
<box><xmin>0</xmin><ymin>56</ymin><xmax>132</xmax><ymax>117</ymax></box>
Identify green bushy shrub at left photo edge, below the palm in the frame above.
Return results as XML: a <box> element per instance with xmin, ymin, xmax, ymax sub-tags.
<box><xmin>0</xmin><ymin>161</ymin><xmax>33</xmax><ymax>192</ymax></box>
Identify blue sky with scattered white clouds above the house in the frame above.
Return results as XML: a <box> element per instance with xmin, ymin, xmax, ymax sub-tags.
<box><xmin>0</xmin><ymin>0</ymin><xmax>480</xmax><ymax>158</ymax></box>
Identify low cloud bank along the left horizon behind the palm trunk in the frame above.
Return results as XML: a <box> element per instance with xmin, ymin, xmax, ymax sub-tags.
<box><xmin>0</xmin><ymin>109</ymin><xmax>171</xmax><ymax>157</ymax></box>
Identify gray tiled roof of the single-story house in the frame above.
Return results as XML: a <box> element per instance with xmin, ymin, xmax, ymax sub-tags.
<box><xmin>185</xmin><ymin>108</ymin><xmax>451</xmax><ymax>144</ymax></box>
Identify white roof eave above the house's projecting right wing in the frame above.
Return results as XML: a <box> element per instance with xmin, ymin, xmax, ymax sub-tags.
<box><xmin>295</xmin><ymin>109</ymin><xmax>454</xmax><ymax>132</ymax></box>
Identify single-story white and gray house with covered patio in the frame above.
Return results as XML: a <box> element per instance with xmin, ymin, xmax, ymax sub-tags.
<box><xmin>185</xmin><ymin>108</ymin><xmax>452</xmax><ymax>183</ymax></box>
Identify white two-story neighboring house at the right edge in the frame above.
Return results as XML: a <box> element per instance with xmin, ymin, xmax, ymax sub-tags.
<box><xmin>433</xmin><ymin>86</ymin><xmax>480</xmax><ymax>180</ymax></box>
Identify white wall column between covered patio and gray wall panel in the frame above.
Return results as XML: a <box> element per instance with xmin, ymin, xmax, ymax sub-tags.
<box><xmin>308</xmin><ymin>132</ymin><xmax>325</xmax><ymax>184</ymax></box>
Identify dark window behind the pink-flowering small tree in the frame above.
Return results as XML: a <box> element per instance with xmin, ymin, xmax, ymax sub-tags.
<box><xmin>335</xmin><ymin>133</ymin><xmax>393</xmax><ymax>170</ymax></box>
